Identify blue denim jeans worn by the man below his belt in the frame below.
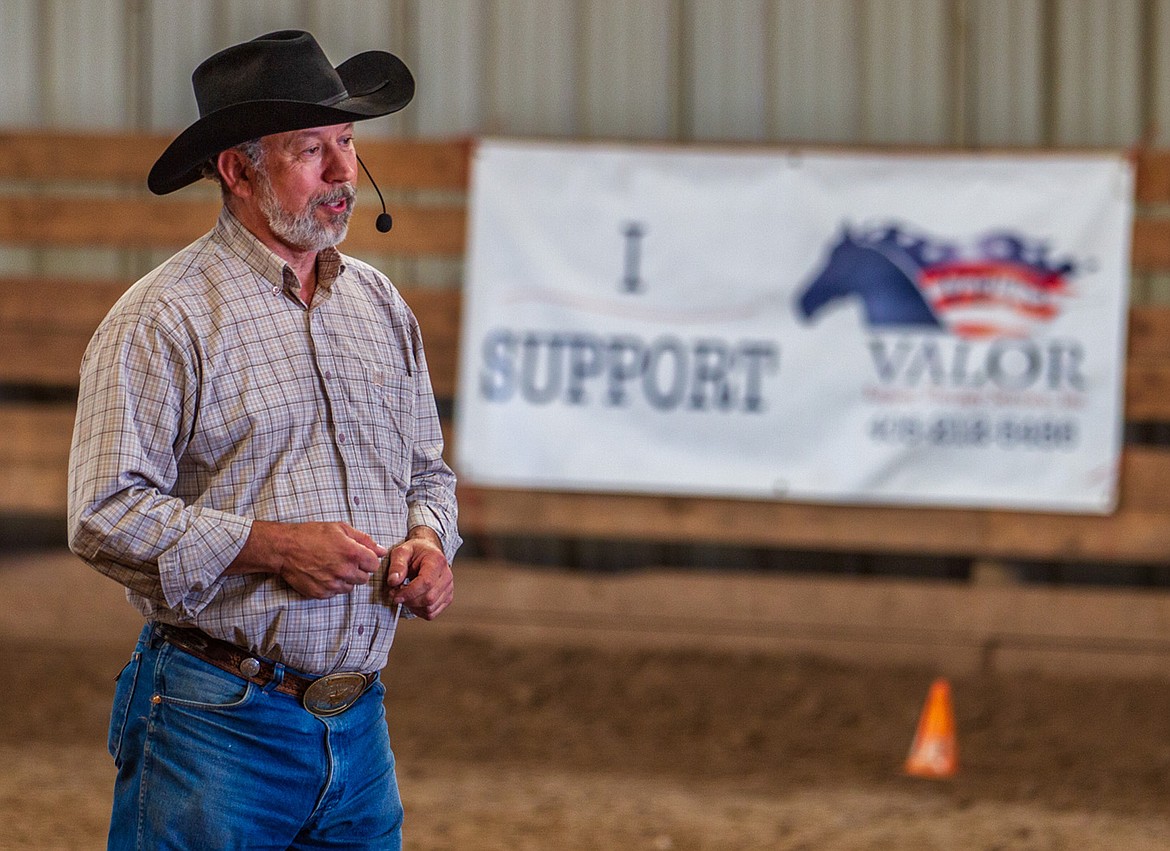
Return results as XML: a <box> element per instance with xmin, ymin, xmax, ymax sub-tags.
<box><xmin>109</xmin><ymin>624</ymin><xmax>402</xmax><ymax>851</ymax></box>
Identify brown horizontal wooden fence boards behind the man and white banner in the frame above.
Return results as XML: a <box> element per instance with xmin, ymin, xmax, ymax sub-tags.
<box><xmin>0</xmin><ymin>132</ymin><xmax>1170</xmax><ymax>564</ymax></box>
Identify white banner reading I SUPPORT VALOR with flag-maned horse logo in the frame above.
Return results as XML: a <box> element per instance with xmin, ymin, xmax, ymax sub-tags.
<box><xmin>455</xmin><ymin>142</ymin><xmax>1133</xmax><ymax>512</ymax></box>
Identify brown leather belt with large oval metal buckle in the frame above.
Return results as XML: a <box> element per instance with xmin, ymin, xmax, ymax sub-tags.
<box><xmin>154</xmin><ymin>623</ymin><xmax>378</xmax><ymax>716</ymax></box>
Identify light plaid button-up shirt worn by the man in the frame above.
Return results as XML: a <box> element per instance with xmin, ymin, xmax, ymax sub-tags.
<box><xmin>69</xmin><ymin>210</ymin><xmax>460</xmax><ymax>674</ymax></box>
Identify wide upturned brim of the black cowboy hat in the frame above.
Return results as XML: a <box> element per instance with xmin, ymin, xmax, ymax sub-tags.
<box><xmin>146</xmin><ymin>50</ymin><xmax>414</xmax><ymax>195</ymax></box>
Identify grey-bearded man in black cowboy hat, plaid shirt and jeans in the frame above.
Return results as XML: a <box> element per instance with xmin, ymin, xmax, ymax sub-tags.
<box><xmin>69</xmin><ymin>32</ymin><xmax>460</xmax><ymax>851</ymax></box>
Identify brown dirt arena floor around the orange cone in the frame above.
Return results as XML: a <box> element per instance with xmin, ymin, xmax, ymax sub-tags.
<box><xmin>0</xmin><ymin>554</ymin><xmax>1170</xmax><ymax>851</ymax></box>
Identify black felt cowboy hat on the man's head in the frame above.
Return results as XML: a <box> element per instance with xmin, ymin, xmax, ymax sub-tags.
<box><xmin>146</xmin><ymin>29</ymin><xmax>414</xmax><ymax>195</ymax></box>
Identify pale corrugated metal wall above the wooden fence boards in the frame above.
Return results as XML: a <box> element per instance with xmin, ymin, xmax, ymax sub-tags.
<box><xmin>0</xmin><ymin>0</ymin><xmax>1170</xmax><ymax>146</ymax></box>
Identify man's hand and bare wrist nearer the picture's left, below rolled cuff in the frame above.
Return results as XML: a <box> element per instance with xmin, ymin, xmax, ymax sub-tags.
<box><xmin>223</xmin><ymin>520</ymin><xmax>388</xmax><ymax>599</ymax></box>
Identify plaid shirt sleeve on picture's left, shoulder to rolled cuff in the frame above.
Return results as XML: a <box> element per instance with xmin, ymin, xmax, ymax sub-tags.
<box><xmin>68</xmin><ymin>311</ymin><xmax>252</xmax><ymax>617</ymax></box>
